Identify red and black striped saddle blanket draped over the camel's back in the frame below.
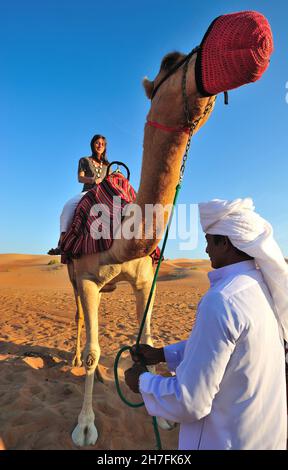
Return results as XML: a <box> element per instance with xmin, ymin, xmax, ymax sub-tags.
<box><xmin>61</xmin><ymin>173</ymin><xmax>160</xmax><ymax>263</ymax></box>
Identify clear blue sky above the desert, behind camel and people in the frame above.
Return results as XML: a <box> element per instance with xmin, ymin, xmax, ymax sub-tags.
<box><xmin>0</xmin><ymin>0</ymin><xmax>288</xmax><ymax>258</ymax></box>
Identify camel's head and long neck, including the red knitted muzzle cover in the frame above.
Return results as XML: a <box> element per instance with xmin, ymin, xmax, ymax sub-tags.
<box><xmin>107</xmin><ymin>11</ymin><xmax>273</xmax><ymax>262</ymax></box>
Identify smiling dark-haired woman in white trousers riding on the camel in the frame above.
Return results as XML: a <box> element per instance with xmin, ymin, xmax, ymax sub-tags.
<box><xmin>48</xmin><ymin>134</ymin><xmax>109</xmax><ymax>255</ymax></box>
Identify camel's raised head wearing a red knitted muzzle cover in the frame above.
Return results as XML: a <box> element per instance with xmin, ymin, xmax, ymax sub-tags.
<box><xmin>143</xmin><ymin>11</ymin><xmax>273</xmax><ymax>133</ymax></box>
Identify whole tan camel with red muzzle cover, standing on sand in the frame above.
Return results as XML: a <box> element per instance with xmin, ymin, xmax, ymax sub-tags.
<box><xmin>69</xmin><ymin>12</ymin><xmax>273</xmax><ymax>446</ymax></box>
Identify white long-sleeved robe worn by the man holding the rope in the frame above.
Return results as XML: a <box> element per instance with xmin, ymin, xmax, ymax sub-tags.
<box><xmin>139</xmin><ymin>261</ymin><xmax>287</xmax><ymax>450</ymax></box>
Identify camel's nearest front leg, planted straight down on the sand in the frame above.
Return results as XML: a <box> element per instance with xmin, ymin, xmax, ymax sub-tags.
<box><xmin>72</xmin><ymin>279</ymin><xmax>100</xmax><ymax>446</ymax></box>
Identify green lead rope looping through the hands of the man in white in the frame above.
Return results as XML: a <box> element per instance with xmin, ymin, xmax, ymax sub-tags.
<box><xmin>114</xmin><ymin>183</ymin><xmax>181</xmax><ymax>450</ymax></box>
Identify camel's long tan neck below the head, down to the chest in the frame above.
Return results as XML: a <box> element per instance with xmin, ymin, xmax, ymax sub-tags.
<box><xmin>109</xmin><ymin>125</ymin><xmax>188</xmax><ymax>263</ymax></box>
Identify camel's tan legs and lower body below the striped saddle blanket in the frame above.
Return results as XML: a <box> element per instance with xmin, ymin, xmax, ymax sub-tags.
<box><xmin>68</xmin><ymin>254</ymin><xmax>160</xmax><ymax>446</ymax></box>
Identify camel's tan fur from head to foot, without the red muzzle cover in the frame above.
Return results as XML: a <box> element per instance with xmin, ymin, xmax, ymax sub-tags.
<box><xmin>69</xmin><ymin>49</ymin><xmax>214</xmax><ymax>445</ymax></box>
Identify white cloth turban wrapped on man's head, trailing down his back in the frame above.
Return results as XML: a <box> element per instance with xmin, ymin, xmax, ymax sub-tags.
<box><xmin>199</xmin><ymin>198</ymin><xmax>288</xmax><ymax>341</ymax></box>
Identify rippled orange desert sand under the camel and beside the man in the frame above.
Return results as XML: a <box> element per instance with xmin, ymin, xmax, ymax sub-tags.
<box><xmin>0</xmin><ymin>254</ymin><xmax>210</xmax><ymax>450</ymax></box>
